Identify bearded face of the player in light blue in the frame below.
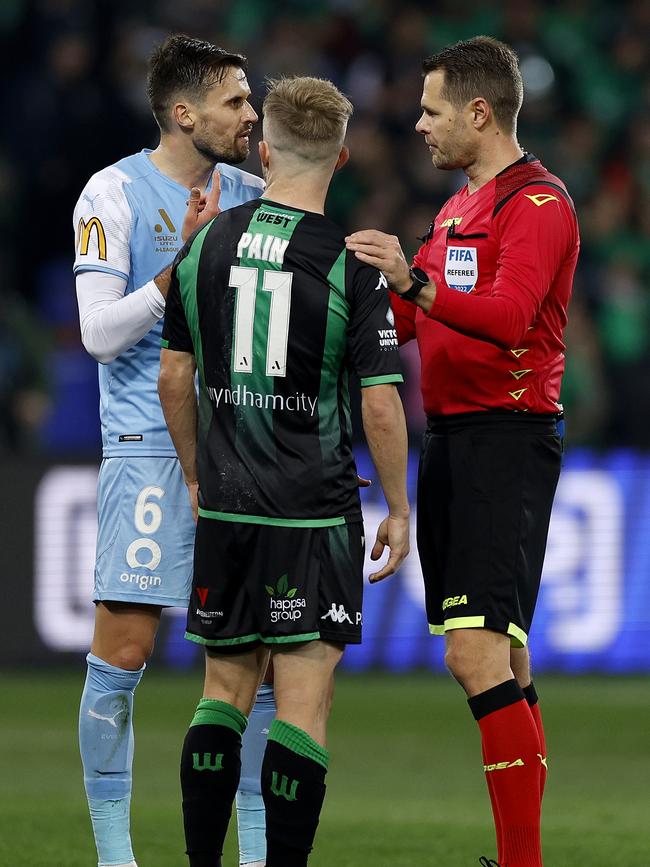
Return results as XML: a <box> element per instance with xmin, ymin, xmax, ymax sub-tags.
<box><xmin>192</xmin><ymin>68</ymin><xmax>258</xmax><ymax>165</ymax></box>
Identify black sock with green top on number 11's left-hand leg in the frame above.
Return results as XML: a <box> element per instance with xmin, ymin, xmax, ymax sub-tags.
<box><xmin>181</xmin><ymin>698</ymin><xmax>247</xmax><ymax>867</ymax></box>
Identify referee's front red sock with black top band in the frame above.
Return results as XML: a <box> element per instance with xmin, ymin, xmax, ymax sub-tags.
<box><xmin>468</xmin><ymin>678</ymin><xmax>542</xmax><ymax>867</ymax></box>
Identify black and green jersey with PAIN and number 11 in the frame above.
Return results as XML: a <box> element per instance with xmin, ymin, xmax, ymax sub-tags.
<box><xmin>163</xmin><ymin>199</ymin><xmax>402</xmax><ymax>527</ymax></box>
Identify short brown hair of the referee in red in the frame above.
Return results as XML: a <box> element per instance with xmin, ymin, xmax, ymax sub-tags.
<box><xmin>422</xmin><ymin>36</ymin><xmax>524</xmax><ymax>133</ymax></box>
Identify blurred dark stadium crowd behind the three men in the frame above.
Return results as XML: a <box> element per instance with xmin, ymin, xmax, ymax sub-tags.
<box><xmin>0</xmin><ymin>0</ymin><xmax>650</xmax><ymax>455</ymax></box>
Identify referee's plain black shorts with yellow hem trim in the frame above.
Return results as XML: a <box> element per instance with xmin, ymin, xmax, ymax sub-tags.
<box><xmin>417</xmin><ymin>412</ymin><xmax>562</xmax><ymax>647</ymax></box>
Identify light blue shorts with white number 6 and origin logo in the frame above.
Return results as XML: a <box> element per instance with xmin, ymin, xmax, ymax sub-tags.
<box><xmin>93</xmin><ymin>457</ymin><xmax>196</xmax><ymax>608</ymax></box>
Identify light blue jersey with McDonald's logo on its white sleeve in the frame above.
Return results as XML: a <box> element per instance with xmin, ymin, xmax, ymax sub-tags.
<box><xmin>74</xmin><ymin>150</ymin><xmax>263</xmax><ymax>457</ymax></box>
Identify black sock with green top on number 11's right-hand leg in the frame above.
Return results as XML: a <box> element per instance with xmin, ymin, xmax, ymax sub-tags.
<box><xmin>262</xmin><ymin>719</ymin><xmax>329</xmax><ymax>867</ymax></box>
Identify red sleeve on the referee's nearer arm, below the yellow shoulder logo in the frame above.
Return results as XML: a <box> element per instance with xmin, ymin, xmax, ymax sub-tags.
<box><xmin>427</xmin><ymin>184</ymin><xmax>576</xmax><ymax>349</ymax></box>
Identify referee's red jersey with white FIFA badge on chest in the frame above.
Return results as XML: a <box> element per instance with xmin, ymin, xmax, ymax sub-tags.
<box><xmin>391</xmin><ymin>154</ymin><xmax>580</xmax><ymax>416</ymax></box>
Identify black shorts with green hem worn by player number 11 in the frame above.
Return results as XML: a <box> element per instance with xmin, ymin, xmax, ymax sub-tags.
<box><xmin>185</xmin><ymin>517</ymin><xmax>364</xmax><ymax>653</ymax></box>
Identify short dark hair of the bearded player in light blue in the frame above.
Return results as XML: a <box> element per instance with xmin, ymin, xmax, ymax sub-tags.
<box><xmin>147</xmin><ymin>33</ymin><xmax>247</xmax><ymax>132</ymax></box>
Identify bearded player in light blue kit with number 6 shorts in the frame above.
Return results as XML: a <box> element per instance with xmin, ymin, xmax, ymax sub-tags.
<box><xmin>74</xmin><ymin>36</ymin><xmax>275</xmax><ymax>867</ymax></box>
